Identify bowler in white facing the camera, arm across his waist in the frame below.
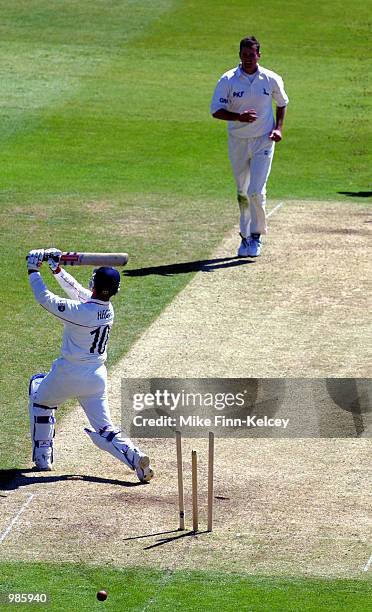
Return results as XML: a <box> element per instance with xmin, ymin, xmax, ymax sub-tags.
<box><xmin>211</xmin><ymin>36</ymin><xmax>288</xmax><ymax>257</ymax></box>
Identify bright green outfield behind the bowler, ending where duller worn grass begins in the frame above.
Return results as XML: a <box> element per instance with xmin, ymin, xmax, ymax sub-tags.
<box><xmin>0</xmin><ymin>0</ymin><xmax>371</xmax><ymax>200</ymax></box>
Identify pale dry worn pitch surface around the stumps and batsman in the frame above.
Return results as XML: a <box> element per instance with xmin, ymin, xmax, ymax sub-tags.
<box><xmin>0</xmin><ymin>202</ymin><xmax>372</xmax><ymax>577</ymax></box>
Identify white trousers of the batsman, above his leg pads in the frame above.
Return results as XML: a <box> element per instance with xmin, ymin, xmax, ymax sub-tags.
<box><xmin>34</xmin><ymin>357</ymin><xmax>114</xmax><ymax>432</ymax></box>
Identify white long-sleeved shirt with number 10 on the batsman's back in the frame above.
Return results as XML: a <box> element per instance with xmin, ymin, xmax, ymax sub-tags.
<box><xmin>29</xmin><ymin>269</ymin><xmax>114</xmax><ymax>365</ymax></box>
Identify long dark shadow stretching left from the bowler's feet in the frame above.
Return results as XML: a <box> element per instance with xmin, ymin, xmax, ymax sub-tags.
<box><xmin>123</xmin><ymin>257</ymin><xmax>254</xmax><ymax>276</ymax></box>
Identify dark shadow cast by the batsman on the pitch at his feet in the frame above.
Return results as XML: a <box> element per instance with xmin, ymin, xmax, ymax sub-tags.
<box><xmin>0</xmin><ymin>469</ymin><xmax>140</xmax><ymax>491</ymax></box>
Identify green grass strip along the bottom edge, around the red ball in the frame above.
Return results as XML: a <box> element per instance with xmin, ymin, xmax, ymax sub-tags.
<box><xmin>0</xmin><ymin>563</ymin><xmax>372</xmax><ymax>612</ymax></box>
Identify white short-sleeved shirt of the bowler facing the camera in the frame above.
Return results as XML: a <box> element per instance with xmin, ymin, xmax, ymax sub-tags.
<box><xmin>211</xmin><ymin>66</ymin><xmax>288</xmax><ymax>138</ymax></box>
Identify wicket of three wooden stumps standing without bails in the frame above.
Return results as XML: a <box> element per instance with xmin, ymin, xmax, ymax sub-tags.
<box><xmin>176</xmin><ymin>431</ymin><xmax>214</xmax><ymax>533</ymax></box>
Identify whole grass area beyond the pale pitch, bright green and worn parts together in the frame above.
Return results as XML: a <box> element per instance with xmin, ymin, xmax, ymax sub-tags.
<box><xmin>0</xmin><ymin>0</ymin><xmax>372</xmax><ymax>468</ymax></box>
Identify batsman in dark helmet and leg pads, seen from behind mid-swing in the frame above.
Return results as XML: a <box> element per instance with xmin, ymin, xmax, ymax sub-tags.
<box><xmin>27</xmin><ymin>248</ymin><xmax>154</xmax><ymax>482</ymax></box>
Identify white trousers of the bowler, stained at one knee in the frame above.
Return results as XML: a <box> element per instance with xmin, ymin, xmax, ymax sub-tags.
<box><xmin>228</xmin><ymin>134</ymin><xmax>275</xmax><ymax>237</ymax></box>
